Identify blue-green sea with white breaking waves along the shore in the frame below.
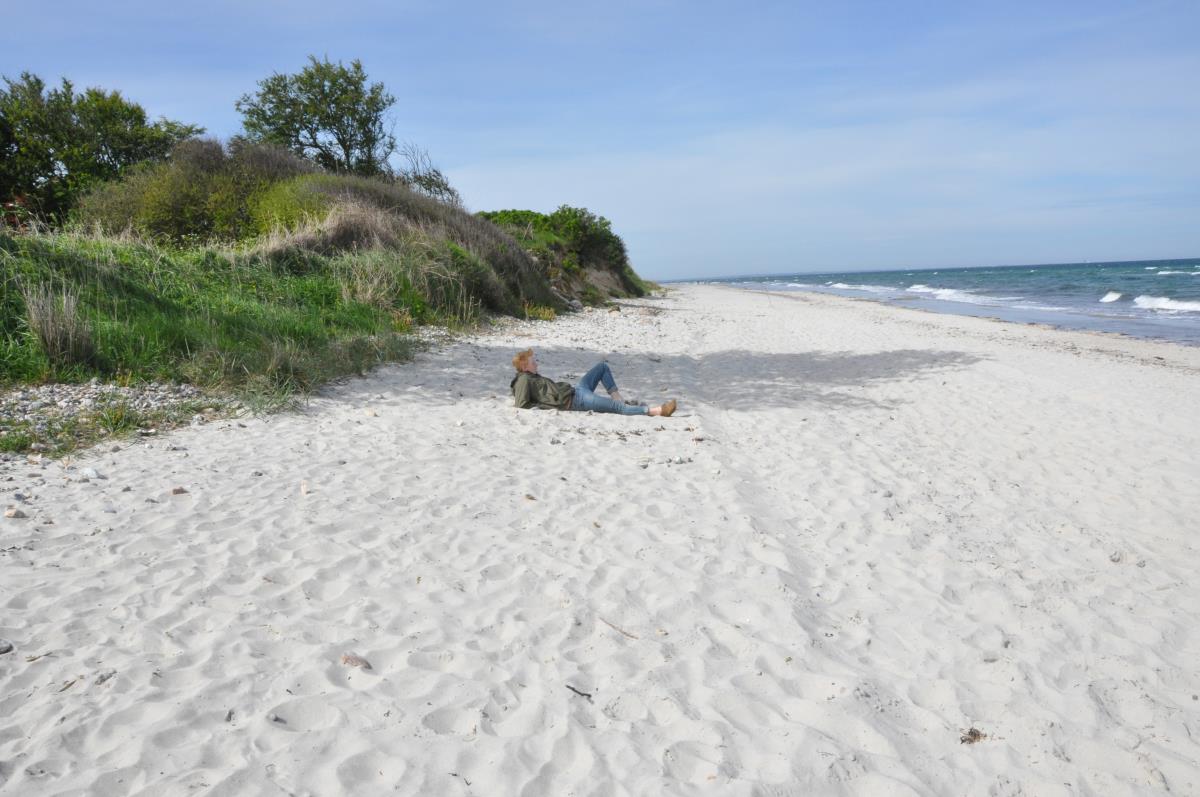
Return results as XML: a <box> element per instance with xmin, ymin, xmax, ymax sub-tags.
<box><xmin>706</xmin><ymin>258</ymin><xmax>1200</xmax><ymax>346</ymax></box>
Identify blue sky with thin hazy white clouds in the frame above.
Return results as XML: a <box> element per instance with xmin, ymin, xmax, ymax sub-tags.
<box><xmin>0</xmin><ymin>0</ymin><xmax>1200</xmax><ymax>280</ymax></box>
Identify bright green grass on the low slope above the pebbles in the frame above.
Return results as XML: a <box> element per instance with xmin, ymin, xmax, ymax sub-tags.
<box><xmin>0</xmin><ymin>233</ymin><xmax>420</xmax><ymax>395</ymax></box>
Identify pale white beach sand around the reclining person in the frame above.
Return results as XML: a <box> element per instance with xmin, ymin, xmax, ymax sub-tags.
<box><xmin>0</xmin><ymin>287</ymin><xmax>1200</xmax><ymax>796</ymax></box>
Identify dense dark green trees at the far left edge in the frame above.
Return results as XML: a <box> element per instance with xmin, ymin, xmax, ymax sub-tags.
<box><xmin>0</xmin><ymin>72</ymin><xmax>204</xmax><ymax>220</ymax></box>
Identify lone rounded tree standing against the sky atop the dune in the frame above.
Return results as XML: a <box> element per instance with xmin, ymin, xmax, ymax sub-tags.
<box><xmin>235</xmin><ymin>55</ymin><xmax>396</xmax><ymax>176</ymax></box>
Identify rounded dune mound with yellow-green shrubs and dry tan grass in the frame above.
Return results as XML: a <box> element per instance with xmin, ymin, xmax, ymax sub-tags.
<box><xmin>74</xmin><ymin>140</ymin><xmax>560</xmax><ymax>313</ymax></box>
